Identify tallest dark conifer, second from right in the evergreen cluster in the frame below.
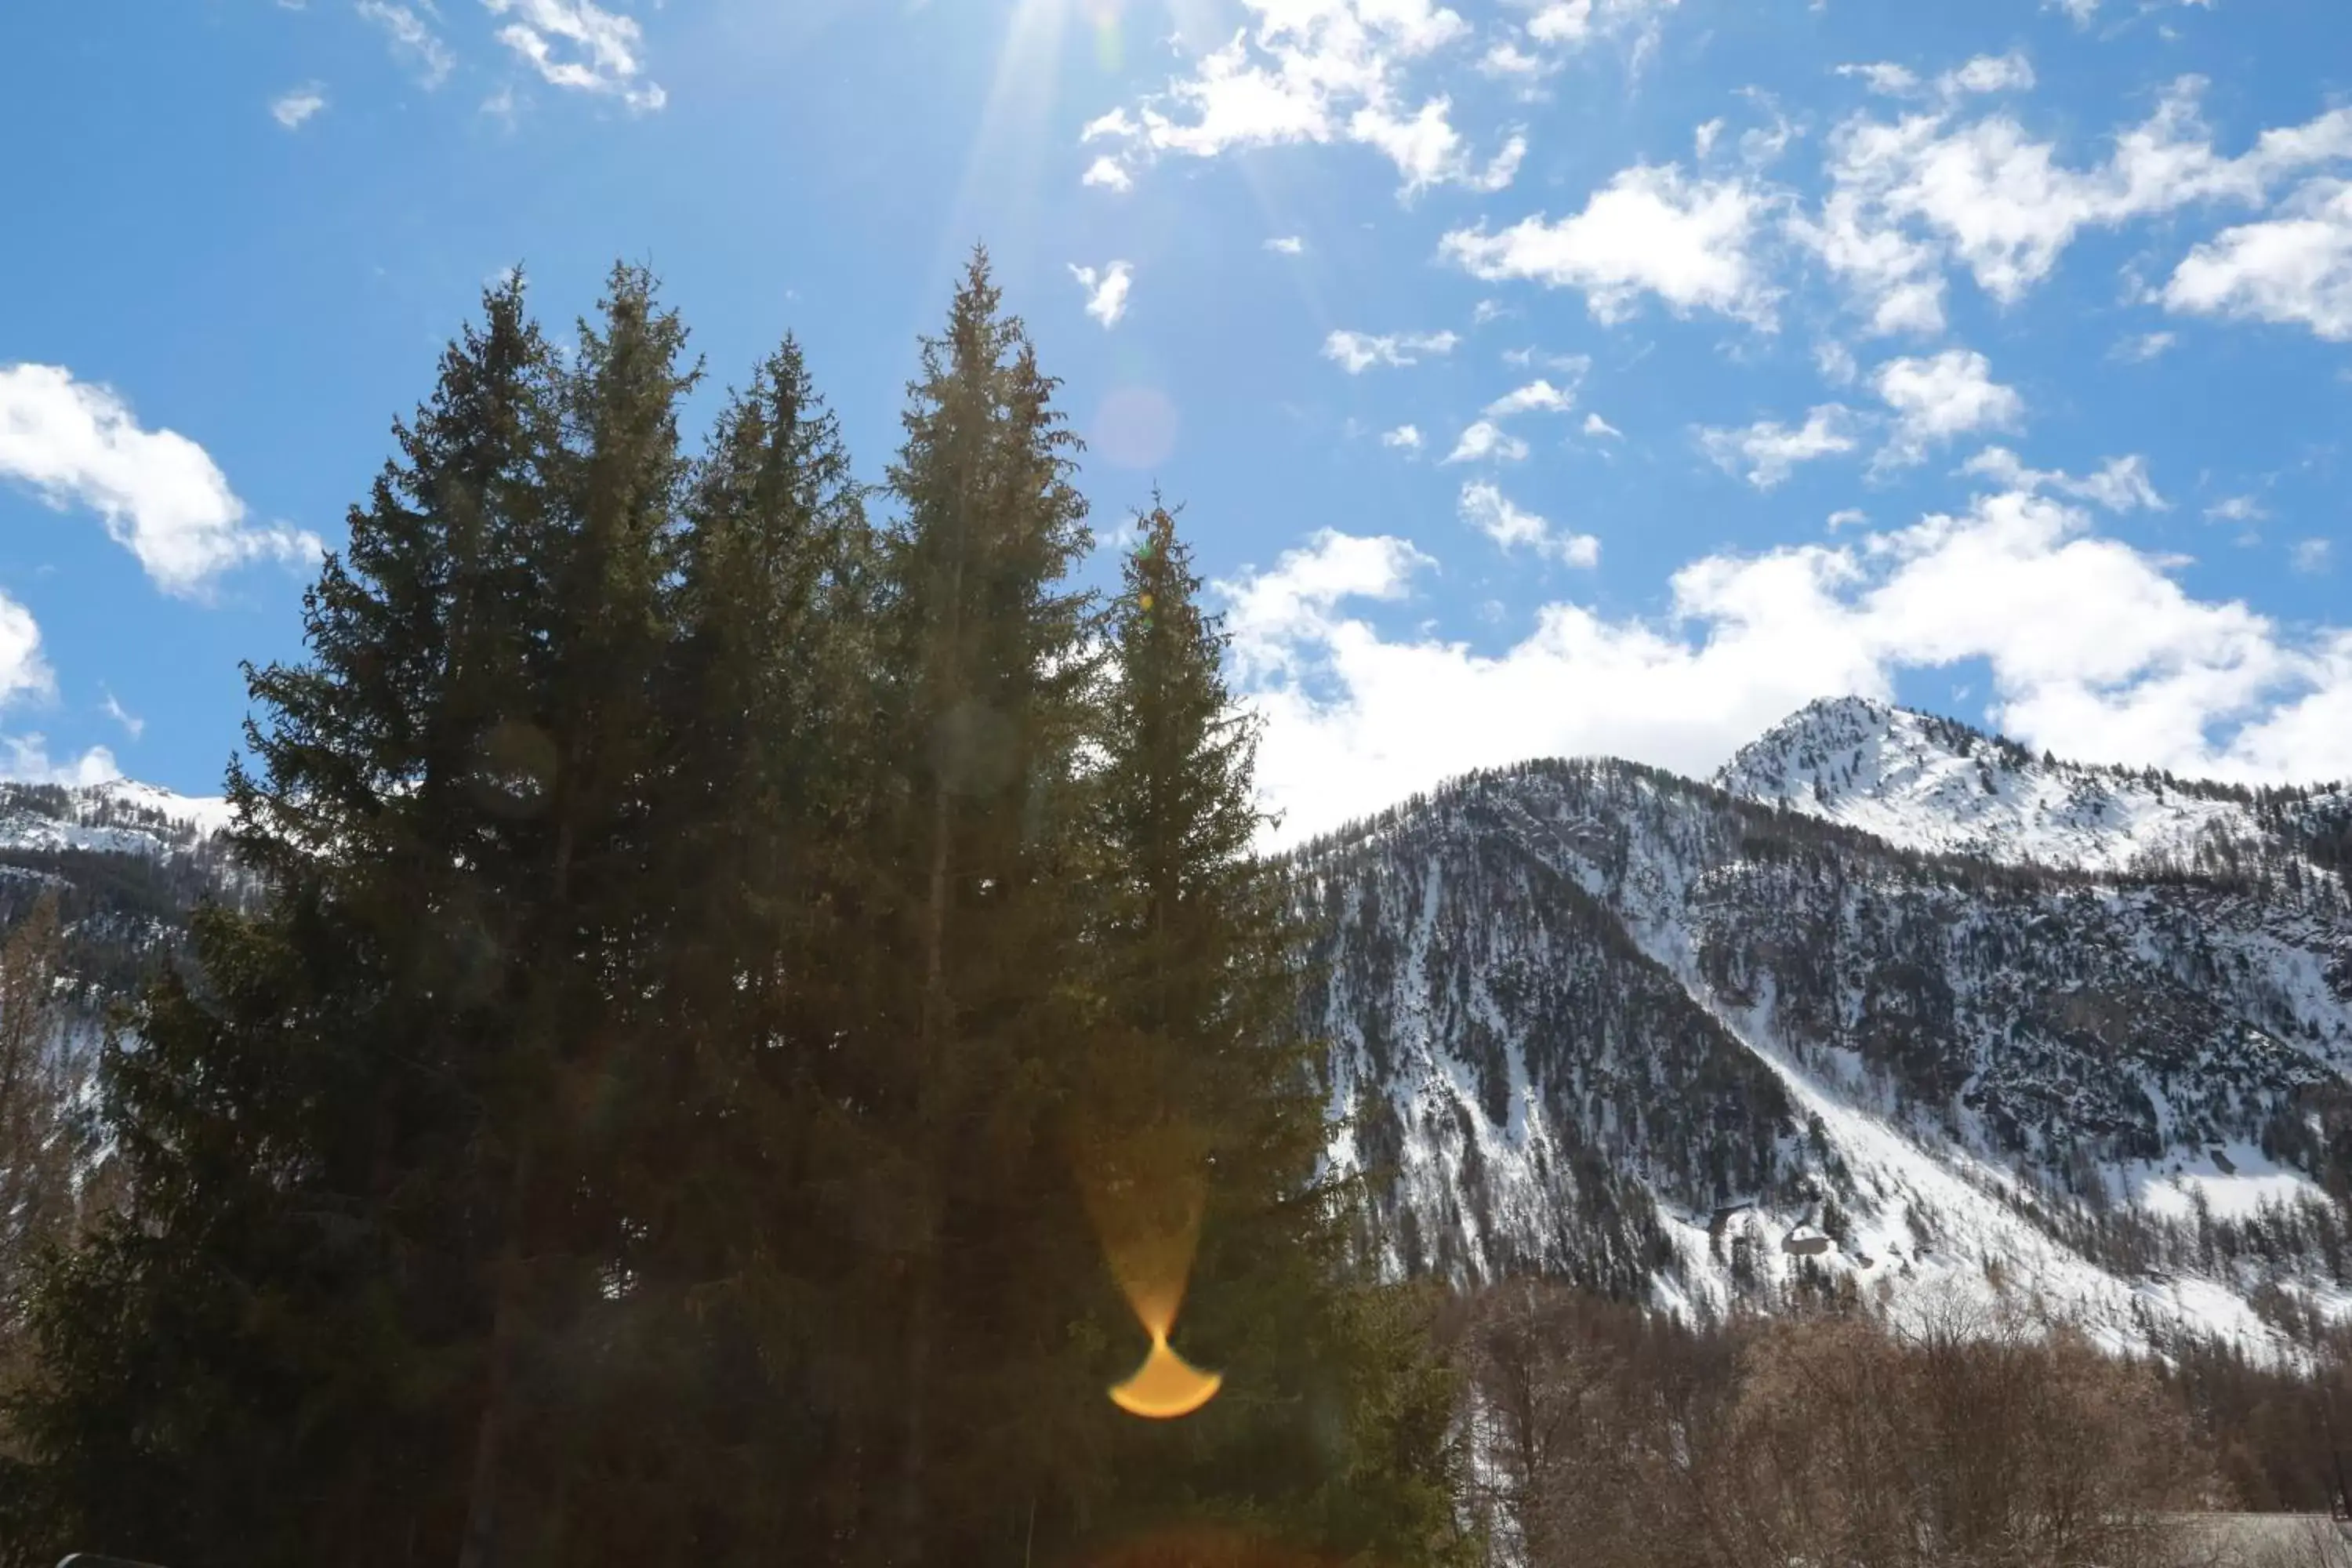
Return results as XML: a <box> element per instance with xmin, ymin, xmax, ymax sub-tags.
<box><xmin>858</xmin><ymin>254</ymin><xmax>1098</xmax><ymax>1563</ymax></box>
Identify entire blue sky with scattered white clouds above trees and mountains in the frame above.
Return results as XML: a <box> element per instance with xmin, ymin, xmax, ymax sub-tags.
<box><xmin>0</xmin><ymin>0</ymin><xmax>2352</xmax><ymax>832</ymax></box>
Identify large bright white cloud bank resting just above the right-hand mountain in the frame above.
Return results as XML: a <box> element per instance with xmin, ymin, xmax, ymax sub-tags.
<box><xmin>1223</xmin><ymin>492</ymin><xmax>2352</xmax><ymax>841</ymax></box>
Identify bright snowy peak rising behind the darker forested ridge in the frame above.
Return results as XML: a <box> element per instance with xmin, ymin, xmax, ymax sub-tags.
<box><xmin>1715</xmin><ymin>696</ymin><xmax>2263</xmax><ymax>872</ymax></box>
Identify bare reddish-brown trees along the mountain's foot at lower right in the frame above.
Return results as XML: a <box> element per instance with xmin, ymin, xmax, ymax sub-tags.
<box><xmin>1442</xmin><ymin>1281</ymin><xmax>2352</xmax><ymax>1568</ymax></box>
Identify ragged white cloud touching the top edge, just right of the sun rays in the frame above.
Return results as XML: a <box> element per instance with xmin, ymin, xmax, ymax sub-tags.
<box><xmin>1082</xmin><ymin>0</ymin><xmax>1526</xmax><ymax>195</ymax></box>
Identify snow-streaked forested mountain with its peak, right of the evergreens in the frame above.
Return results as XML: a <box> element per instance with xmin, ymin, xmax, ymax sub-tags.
<box><xmin>1298</xmin><ymin>701</ymin><xmax>2352</xmax><ymax>1349</ymax></box>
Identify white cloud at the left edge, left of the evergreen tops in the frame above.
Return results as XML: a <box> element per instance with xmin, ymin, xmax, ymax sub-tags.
<box><xmin>0</xmin><ymin>365</ymin><xmax>320</xmax><ymax>597</ymax></box>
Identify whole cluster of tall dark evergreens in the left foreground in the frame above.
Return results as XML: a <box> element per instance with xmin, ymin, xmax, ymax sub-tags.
<box><xmin>0</xmin><ymin>254</ymin><xmax>1472</xmax><ymax>1568</ymax></box>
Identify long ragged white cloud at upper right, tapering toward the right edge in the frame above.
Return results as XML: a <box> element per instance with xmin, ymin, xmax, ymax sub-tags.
<box><xmin>1790</xmin><ymin>79</ymin><xmax>2352</xmax><ymax>332</ymax></box>
